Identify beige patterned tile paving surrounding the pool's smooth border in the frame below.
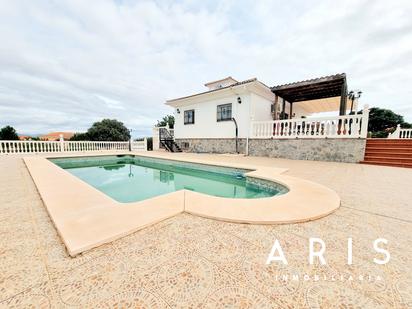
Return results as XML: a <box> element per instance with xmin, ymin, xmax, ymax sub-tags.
<box><xmin>0</xmin><ymin>153</ymin><xmax>412</xmax><ymax>308</ymax></box>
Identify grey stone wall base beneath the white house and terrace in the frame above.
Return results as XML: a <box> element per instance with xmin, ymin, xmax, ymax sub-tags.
<box><xmin>176</xmin><ymin>138</ymin><xmax>366</xmax><ymax>163</ymax></box>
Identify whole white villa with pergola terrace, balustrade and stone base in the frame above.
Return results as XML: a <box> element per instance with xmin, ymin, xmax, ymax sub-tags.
<box><xmin>160</xmin><ymin>74</ymin><xmax>368</xmax><ymax>162</ymax></box>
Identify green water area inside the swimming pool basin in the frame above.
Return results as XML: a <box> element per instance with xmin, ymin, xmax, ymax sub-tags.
<box><xmin>50</xmin><ymin>156</ymin><xmax>287</xmax><ymax>203</ymax></box>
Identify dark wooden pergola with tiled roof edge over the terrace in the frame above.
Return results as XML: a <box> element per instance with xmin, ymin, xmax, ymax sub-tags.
<box><xmin>271</xmin><ymin>73</ymin><xmax>348</xmax><ymax>120</ymax></box>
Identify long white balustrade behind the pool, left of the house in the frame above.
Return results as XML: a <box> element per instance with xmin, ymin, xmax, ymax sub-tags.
<box><xmin>0</xmin><ymin>139</ymin><xmax>147</xmax><ymax>154</ymax></box>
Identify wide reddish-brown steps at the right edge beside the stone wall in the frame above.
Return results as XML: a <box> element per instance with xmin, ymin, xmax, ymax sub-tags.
<box><xmin>360</xmin><ymin>138</ymin><xmax>412</xmax><ymax>168</ymax></box>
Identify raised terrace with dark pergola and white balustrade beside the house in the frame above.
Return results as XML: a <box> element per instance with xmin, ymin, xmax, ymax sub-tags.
<box><xmin>251</xmin><ymin>74</ymin><xmax>369</xmax><ymax>139</ymax></box>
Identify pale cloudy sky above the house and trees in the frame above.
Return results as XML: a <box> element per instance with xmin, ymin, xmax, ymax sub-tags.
<box><xmin>0</xmin><ymin>0</ymin><xmax>412</xmax><ymax>137</ymax></box>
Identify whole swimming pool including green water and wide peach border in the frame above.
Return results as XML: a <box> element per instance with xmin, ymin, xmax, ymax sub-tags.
<box><xmin>23</xmin><ymin>152</ymin><xmax>340</xmax><ymax>256</ymax></box>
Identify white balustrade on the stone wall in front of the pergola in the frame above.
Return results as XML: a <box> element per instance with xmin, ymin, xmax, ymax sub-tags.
<box><xmin>251</xmin><ymin>107</ymin><xmax>369</xmax><ymax>139</ymax></box>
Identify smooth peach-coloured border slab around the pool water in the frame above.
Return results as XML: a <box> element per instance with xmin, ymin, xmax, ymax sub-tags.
<box><xmin>24</xmin><ymin>152</ymin><xmax>340</xmax><ymax>257</ymax></box>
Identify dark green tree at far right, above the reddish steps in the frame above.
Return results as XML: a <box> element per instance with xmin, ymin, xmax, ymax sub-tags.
<box><xmin>368</xmin><ymin>107</ymin><xmax>411</xmax><ymax>137</ymax></box>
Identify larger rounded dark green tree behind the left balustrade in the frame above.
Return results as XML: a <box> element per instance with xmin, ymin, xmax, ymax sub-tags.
<box><xmin>86</xmin><ymin>119</ymin><xmax>130</xmax><ymax>141</ymax></box>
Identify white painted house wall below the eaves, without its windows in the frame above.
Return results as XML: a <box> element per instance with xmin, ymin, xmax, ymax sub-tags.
<box><xmin>174</xmin><ymin>91</ymin><xmax>272</xmax><ymax>139</ymax></box>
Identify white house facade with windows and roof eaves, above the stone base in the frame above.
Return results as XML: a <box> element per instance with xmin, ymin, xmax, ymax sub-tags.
<box><xmin>166</xmin><ymin>79</ymin><xmax>275</xmax><ymax>139</ymax></box>
